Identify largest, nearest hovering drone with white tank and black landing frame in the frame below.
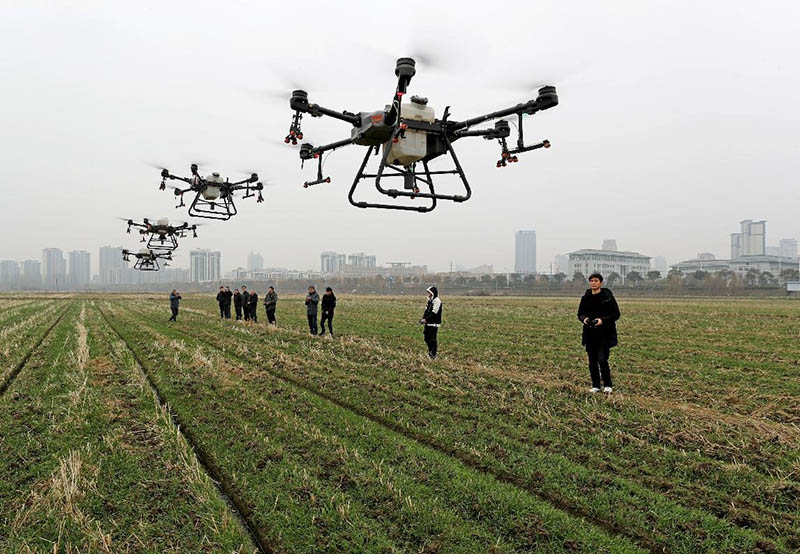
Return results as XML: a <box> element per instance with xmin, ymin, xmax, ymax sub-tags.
<box><xmin>284</xmin><ymin>58</ymin><xmax>558</xmax><ymax>212</ymax></box>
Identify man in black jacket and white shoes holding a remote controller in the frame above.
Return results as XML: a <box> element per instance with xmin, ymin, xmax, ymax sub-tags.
<box><xmin>578</xmin><ymin>273</ymin><xmax>619</xmax><ymax>393</ymax></box>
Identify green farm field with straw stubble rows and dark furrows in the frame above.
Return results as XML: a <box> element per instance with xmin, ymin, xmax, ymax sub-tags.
<box><xmin>0</xmin><ymin>291</ymin><xmax>800</xmax><ymax>554</ymax></box>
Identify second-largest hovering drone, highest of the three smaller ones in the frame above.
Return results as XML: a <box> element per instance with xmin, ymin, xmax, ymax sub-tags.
<box><xmin>159</xmin><ymin>164</ymin><xmax>264</xmax><ymax>221</ymax></box>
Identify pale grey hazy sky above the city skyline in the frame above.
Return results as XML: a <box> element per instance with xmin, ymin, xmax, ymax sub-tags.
<box><xmin>0</xmin><ymin>0</ymin><xmax>800</xmax><ymax>271</ymax></box>
